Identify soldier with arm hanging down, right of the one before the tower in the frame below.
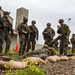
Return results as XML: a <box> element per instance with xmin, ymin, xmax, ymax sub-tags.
<box><xmin>27</xmin><ymin>20</ymin><xmax>39</xmax><ymax>52</ymax></box>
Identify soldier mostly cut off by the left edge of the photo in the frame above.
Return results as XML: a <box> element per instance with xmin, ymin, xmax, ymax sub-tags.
<box><xmin>0</xmin><ymin>7</ymin><xmax>4</xmax><ymax>55</ymax></box>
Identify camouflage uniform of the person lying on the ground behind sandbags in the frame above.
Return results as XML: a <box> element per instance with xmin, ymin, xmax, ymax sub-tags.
<box><xmin>23</xmin><ymin>44</ymin><xmax>55</xmax><ymax>59</ymax></box>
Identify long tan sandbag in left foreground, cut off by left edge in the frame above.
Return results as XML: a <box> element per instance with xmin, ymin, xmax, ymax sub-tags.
<box><xmin>0</xmin><ymin>60</ymin><xmax>27</xmax><ymax>69</ymax></box>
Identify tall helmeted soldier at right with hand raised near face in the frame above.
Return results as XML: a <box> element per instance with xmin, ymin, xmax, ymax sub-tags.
<box><xmin>57</xmin><ymin>19</ymin><xmax>71</xmax><ymax>55</ymax></box>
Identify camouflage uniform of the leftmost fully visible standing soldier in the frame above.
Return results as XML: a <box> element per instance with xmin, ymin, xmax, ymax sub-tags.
<box><xmin>2</xmin><ymin>17</ymin><xmax>11</xmax><ymax>53</ymax></box>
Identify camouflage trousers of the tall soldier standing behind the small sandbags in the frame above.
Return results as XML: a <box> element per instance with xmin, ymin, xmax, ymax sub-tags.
<box><xmin>60</xmin><ymin>38</ymin><xmax>68</xmax><ymax>55</ymax></box>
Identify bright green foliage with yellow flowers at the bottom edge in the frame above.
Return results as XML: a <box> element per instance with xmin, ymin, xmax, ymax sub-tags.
<box><xmin>5</xmin><ymin>65</ymin><xmax>45</xmax><ymax>75</ymax></box>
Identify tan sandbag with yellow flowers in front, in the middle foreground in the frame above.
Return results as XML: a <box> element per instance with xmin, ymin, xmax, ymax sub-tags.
<box><xmin>23</xmin><ymin>57</ymin><xmax>46</xmax><ymax>65</ymax></box>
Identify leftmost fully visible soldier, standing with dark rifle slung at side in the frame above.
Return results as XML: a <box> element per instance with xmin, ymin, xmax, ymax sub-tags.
<box><xmin>2</xmin><ymin>11</ymin><xmax>13</xmax><ymax>54</ymax></box>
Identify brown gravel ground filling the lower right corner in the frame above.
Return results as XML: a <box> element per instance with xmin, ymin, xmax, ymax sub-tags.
<box><xmin>42</xmin><ymin>60</ymin><xmax>75</xmax><ymax>75</ymax></box>
